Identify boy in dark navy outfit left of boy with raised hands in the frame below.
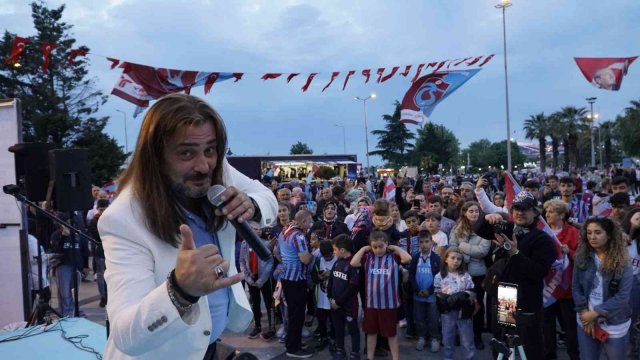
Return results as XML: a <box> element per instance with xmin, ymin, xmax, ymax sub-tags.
<box><xmin>327</xmin><ymin>234</ymin><xmax>360</xmax><ymax>360</ymax></box>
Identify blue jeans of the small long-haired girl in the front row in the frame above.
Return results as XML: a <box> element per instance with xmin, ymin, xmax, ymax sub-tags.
<box><xmin>440</xmin><ymin>311</ymin><xmax>476</xmax><ymax>360</ymax></box>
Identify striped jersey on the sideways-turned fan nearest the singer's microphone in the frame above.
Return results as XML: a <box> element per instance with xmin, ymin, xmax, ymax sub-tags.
<box><xmin>278</xmin><ymin>226</ymin><xmax>309</xmax><ymax>281</ymax></box>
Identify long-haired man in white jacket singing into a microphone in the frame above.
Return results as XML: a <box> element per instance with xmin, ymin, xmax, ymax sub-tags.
<box><xmin>98</xmin><ymin>94</ymin><xmax>277</xmax><ymax>360</ymax></box>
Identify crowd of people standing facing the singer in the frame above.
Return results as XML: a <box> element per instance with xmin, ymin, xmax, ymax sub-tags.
<box><xmin>237</xmin><ymin>169</ymin><xmax>640</xmax><ymax>359</ymax></box>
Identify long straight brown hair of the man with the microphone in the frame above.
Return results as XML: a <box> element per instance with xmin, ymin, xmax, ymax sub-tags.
<box><xmin>118</xmin><ymin>94</ymin><xmax>227</xmax><ymax>247</ymax></box>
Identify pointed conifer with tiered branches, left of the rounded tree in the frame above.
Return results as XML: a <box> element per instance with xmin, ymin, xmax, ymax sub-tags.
<box><xmin>369</xmin><ymin>100</ymin><xmax>415</xmax><ymax>167</ymax></box>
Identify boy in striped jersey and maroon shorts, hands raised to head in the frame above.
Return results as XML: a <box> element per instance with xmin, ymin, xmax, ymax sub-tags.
<box><xmin>351</xmin><ymin>231</ymin><xmax>411</xmax><ymax>360</ymax></box>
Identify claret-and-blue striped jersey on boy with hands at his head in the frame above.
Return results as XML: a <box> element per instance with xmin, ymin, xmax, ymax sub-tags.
<box><xmin>362</xmin><ymin>252</ymin><xmax>400</xmax><ymax>309</ymax></box>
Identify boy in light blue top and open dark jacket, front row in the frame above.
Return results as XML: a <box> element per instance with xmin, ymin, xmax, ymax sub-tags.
<box><xmin>409</xmin><ymin>230</ymin><xmax>440</xmax><ymax>352</ymax></box>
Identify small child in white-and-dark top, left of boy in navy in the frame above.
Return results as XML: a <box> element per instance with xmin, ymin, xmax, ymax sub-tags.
<box><xmin>311</xmin><ymin>240</ymin><xmax>336</xmax><ymax>351</ymax></box>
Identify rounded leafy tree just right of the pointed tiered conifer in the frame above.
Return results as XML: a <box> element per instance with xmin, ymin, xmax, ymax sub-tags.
<box><xmin>407</xmin><ymin>123</ymin><xmax>460</xmax><ymax>173</ymax></box>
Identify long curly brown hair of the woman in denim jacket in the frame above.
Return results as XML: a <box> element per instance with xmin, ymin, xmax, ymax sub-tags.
<box><xmin>575</xmin><ymin>217</ymin><xmax>629</xmax><ymax>276</ymax></box>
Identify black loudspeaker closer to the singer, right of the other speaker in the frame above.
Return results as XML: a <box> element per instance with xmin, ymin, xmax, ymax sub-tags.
<box><xmin>49</xmin><ymin>149</ymin><xmax>93</xmax><ymax>211</ymax></box>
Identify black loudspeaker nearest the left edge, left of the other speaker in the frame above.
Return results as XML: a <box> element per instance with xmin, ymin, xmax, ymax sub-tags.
<box><xmin>9</xmin><ymin>143</ymin><xmax>53</xmax><ymax>202</ymax></box>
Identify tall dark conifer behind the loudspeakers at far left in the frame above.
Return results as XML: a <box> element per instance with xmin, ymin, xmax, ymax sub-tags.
<box><xmin>0</xmin><ymin>1</ymin><xmax>124</xmax><ymax>183</ymax></box>
